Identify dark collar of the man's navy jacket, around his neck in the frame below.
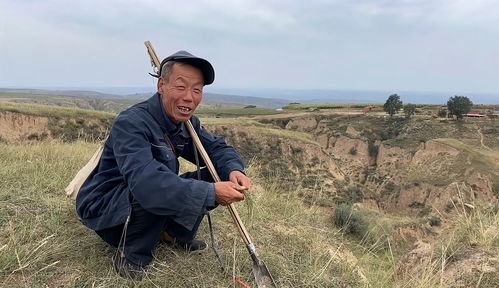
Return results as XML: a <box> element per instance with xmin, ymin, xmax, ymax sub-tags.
<box><xmin>147</xmin><ymin>92</ymin><xmax>190</xmax><ymax>138</ymax></box>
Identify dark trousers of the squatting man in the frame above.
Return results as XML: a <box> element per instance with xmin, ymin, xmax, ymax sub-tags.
<box><xmin>95</xmin><ymin>169</ymin><xmax>213</xmax><ymax>266</ymax></box>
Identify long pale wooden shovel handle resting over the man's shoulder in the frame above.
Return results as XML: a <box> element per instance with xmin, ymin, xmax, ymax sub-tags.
<box><xmin>144</xmin><ymin>41</ymin><xmax>256</xmax><ymax>248</ymax></box>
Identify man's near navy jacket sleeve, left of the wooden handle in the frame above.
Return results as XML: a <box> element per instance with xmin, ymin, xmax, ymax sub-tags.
<box><xmin>111</xmin><ymin>110</ymin><xmax>215</xmax><ymax>230</ymax></box>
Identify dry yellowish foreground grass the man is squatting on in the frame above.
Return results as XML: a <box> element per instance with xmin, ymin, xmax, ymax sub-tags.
<box><xmin>0</xmin><ymin>142</ymin><xmax>358</xmax><ymax>287</ymax></box>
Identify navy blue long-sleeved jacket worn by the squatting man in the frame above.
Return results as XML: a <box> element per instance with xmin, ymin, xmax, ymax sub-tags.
<box><xmin>76</xmin><ymin>93</ymin><xmax>244</xmax><ymax>230</ymax></box>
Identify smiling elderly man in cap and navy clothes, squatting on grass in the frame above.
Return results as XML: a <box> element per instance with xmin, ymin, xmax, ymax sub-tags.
<box><xmin>76</xmin><ymin>51</ymin><xmax>251</xmax><ymax>279</ymax></box>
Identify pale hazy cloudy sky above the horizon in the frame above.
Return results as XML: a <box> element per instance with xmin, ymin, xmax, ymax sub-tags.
<box><xmin>0</xmin><ymin>0</ymin><xmax>499</xmax><ymax>93</ymax></box>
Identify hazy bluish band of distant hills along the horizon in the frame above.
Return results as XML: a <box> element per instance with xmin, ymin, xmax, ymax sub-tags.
<box><xmin>0</xmin><ymin>87</ymin><xmax>499</xmax><ymax>108</ymax></box>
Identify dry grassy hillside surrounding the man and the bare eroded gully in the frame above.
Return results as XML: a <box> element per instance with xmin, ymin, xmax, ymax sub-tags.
<box><xmin>0</xmin><ymin>103</ymin><xmax>499</xmax><ymax>288</ymax></box>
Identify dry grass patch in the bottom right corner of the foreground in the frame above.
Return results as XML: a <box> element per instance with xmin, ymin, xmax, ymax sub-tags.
<box><xmin>396</xmin><ymin>183</ymin><xmax>499</xmax><ymax>288</ymax></box>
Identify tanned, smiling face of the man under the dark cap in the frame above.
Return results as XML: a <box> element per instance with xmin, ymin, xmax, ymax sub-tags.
<box><xmin>158</xmin><ymin>63</ymin><xmax>204</xmax><ymax>123</ymax></box>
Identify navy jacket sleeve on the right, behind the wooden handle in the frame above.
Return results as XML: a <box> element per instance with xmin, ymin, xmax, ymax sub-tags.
<box><xmin>191</xmin><ymin>117</ymin><xmax>244</xmax><ymax>181</ymax></box>
